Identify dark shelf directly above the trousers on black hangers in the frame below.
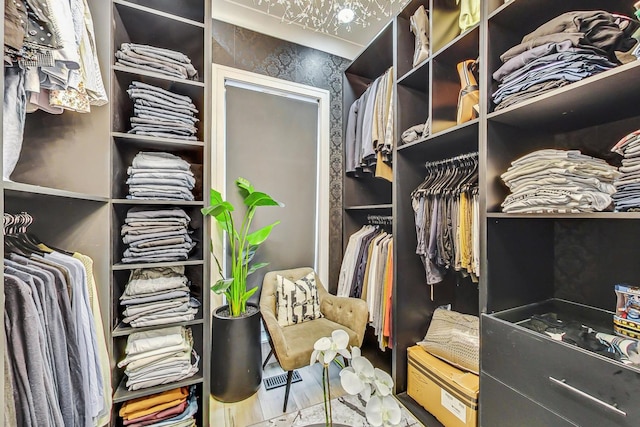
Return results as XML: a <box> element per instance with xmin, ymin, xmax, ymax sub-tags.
<box><xmin>398</xmin><ymin>119</ymin><xmax>479</xmax><ymax>158</ymax></box>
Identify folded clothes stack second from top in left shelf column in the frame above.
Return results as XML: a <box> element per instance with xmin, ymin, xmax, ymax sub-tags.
<box><xmin>127</xmin><ymin>81</ymin><xmax>199</xmax><ymax>141</ymax></box>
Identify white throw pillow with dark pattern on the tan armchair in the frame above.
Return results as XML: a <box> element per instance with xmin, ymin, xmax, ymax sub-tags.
<box><xmin>276</xmin><ymin>271</ymin><xmax>324</xmax><ymax>326</ymax></box>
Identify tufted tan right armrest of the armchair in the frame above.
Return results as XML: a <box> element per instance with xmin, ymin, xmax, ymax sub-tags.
<box><xmin>320</xmin><ymin>293</ymin><xmax>369</xmax><ymax>346</ymax></box>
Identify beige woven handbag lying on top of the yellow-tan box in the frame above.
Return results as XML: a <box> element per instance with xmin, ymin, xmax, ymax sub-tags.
<box><xmin>417</xmin><ymin>308</ymin><xmax>480</xmax><ymax>374</ymax></box>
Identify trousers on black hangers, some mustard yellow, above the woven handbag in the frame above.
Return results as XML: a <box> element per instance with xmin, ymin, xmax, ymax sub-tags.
<box><xmin>411</xmin><ymin>153</ymin><xmax>480</xmax><ymax>285</ymax></box>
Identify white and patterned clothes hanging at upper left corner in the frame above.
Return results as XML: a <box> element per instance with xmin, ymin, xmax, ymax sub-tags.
<box><xmin>2</xmin><ymin>0</ymin><xmax>108</xmax><ymax>181</ymax></box>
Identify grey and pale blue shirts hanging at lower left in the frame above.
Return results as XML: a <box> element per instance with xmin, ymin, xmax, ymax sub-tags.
<box><xmin>4</xmin><ymin>214</ymin><xmax>112</xmax><ymax>426</ymax></box>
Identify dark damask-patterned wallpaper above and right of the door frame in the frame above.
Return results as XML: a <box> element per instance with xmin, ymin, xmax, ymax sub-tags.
<box><xmin>213</xmin><ymin>20</ymin><xmax>350</xmax><ymax>287</ymax></box>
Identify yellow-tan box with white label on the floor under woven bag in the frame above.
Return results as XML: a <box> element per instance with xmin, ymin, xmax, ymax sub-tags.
<box><xmin>407</xmin><ymin>346</ymin><xmax>480</xmax><ymax>427</ymax></box>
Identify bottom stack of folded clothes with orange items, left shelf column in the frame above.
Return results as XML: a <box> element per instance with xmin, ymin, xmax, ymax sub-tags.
<box><xmin>119</xmin><ymin>386</ymin><xmax>198</xmax><ymax>427</ymax></box>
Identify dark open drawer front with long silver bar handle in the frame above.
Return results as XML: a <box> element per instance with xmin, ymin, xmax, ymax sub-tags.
<box><xmin>481</xmin><ymin>315</ymin><xmax>640</xmax><ymax>427</ymax></box>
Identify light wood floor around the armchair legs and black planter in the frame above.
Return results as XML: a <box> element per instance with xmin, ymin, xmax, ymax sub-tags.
<box><xmin>210</xmin><ymin>346</ymin><xmax>345</xmax><ymax>427</ymax></box>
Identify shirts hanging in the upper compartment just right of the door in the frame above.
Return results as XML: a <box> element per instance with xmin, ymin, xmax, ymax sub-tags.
<box><xmin>345</xmin><ymin>67</ymin><xmax>396</xmax><ymax>181</ymax></box>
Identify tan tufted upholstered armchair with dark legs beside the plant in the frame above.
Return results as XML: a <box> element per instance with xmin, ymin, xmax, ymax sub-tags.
<box><xmin>260</xmin><ymin>267</ymin><xmax>369</xmax><ymax>412</ymax></box>
